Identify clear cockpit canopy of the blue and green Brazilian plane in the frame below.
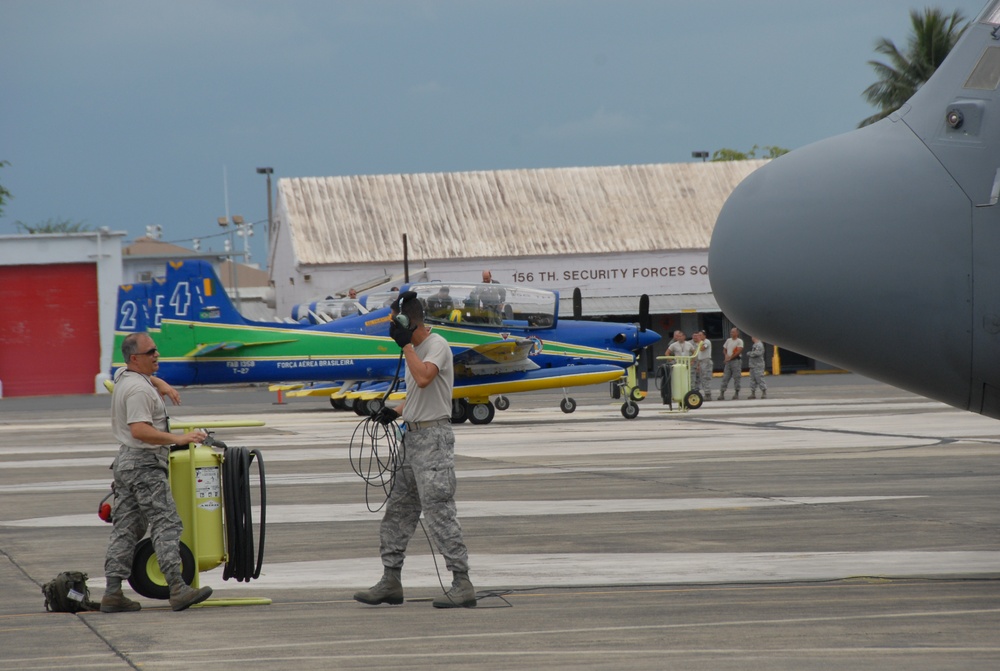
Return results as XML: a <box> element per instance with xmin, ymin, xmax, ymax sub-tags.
<box><xmin>410</xmin><ymin>282</ymin><xmax>558</xmax><ymax>329</ymax></box>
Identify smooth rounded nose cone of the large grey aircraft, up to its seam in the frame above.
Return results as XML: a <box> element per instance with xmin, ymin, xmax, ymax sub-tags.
<box><xmin>709</xmin><ymin>120</ymin><xmax>971</xmax><ymax>407</ymax></box>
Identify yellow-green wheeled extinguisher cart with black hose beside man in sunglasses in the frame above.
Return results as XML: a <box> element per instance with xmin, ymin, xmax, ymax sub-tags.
<box><xmin>112</xmin><ymin>421</ymin><xmax>271</xmax><ymax>606</ymax></box>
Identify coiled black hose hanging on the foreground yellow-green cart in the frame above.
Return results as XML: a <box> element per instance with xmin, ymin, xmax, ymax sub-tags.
<box><xmin>215</xmin><ymin>441</ymin><xmax>267</xmax><ymax>582</ymax></box>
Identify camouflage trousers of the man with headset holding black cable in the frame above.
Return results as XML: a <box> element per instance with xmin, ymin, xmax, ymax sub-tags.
<box><xmin>379</xmin><ymin>424</ymin><xmax>469</xmax><ymax>572</ymax></box>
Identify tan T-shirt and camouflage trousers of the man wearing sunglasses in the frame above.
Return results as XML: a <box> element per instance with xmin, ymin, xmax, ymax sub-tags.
<box><xmin>104</xmin><ymin>371</ymin><xmax>183</xmax><ymax>585</ymax></box>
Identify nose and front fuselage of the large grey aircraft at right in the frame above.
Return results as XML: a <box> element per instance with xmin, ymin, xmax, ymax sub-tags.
<box><xmin>709</xmin><ymin>2</ymin><xmax>1000</xmax><ymax>418</ymax></box>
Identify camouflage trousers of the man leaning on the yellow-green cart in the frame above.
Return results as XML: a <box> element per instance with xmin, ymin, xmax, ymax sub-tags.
<box><xmin>104</xmin><ymin>448</ymin><xmax>183</xmax><ymax>585</ymax></box>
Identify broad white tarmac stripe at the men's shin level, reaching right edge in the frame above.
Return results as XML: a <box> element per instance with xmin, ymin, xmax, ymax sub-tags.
<box><xmin>82</xmin><ymin>543</ymin><xmax>1000</xmax><ymax>596</ymax></box>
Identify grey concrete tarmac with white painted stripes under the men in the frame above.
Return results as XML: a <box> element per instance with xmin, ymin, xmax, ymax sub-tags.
<box><xmin>0</xmin><ymin>374</ymin><xmax>1000</xmax><ymax>671</ymax></box>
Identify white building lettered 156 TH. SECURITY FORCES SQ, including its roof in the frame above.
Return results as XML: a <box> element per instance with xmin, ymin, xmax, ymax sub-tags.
<box><xmin>268</xmin><ymin>160</ymin><xmax>765</xmax><ymax>356</ymax></box>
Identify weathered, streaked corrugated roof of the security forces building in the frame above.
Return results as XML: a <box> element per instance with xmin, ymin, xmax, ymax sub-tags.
<box><xmin>278</xmin><ymin>160</ymin><xmax>766</xmax><ymax>265</ymax></box>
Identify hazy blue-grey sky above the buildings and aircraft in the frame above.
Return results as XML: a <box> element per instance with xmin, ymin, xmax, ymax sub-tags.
<box><xmin>0</xmin><ymin>0</ymin><xmax>986</xmax><ymax>263</ymax></box>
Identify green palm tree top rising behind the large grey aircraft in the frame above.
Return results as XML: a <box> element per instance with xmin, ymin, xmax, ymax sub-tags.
<box><xmin>858</xmin><ymin>8</ymin><xmax>968</xmax><ymax>128</ymax></box>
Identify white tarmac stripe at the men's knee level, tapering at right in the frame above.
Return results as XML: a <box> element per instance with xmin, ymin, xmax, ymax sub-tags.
<box><xmin>0</xmin><ymin>496</ymin><xmax>925</xmax><ymax>529</ymax></box>
